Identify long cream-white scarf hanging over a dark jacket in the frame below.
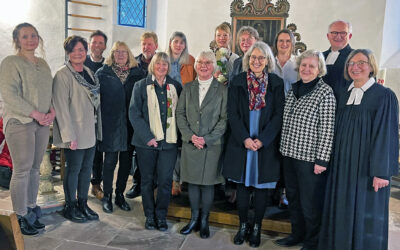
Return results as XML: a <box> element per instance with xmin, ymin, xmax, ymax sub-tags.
<box><xmin>146</xmin><ymin>83</ymin><xmax>178</xmax><ymax>143</ymax></box>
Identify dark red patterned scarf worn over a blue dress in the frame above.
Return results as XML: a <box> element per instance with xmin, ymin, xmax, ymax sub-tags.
<box><xmin>247</xmin><ymin>69</ymin><xmax>268</xmax><ymax>110</ymax></box>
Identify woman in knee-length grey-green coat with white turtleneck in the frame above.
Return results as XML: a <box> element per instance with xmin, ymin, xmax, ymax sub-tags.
<box><xmin>176</xmin><ymin>51</ymin><xmax>228</xmax><ymax>238</ymax></box>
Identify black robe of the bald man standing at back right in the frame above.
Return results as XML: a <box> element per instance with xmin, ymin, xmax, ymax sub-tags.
<box><xmin>322</xmin><ymin>44</ymin><xmax>353</xmax><ymax>99</ymax></box>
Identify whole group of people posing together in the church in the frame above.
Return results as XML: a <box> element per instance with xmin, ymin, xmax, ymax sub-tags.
<box><xmin>0</xmin><ymin>21</ymin><xmax>399</xmax><ymax>250</ymax></box>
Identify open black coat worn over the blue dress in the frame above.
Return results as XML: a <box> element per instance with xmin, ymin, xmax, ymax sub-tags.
<box><xmin>223</xmin><ymin>72</ymin><xmax>285</xmax><ymax>183</ymax></box>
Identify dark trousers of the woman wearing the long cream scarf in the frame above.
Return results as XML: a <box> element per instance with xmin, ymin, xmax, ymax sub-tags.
<box><xmin>136</xmin><ymin>147</ymin><xmax>178</xmax><ymax>219</ymax></box>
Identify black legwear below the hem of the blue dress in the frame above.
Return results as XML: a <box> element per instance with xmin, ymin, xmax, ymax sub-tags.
<box><xmin>236</xmin><ymin>183</ymin><xmax>274</xmax><ymax>225</ymax></box>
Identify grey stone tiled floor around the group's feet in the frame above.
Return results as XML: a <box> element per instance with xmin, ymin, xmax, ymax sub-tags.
<box><xmin>0</xmin><ymin>179</ymin><xmax>400</xmax><ymax>250</ymax></box>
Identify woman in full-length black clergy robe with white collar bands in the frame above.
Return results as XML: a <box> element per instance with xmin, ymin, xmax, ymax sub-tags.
<box><xmin>319</xmin><ymin>49</ymin><xmax>399</xmax><ymax>250</ymax></box>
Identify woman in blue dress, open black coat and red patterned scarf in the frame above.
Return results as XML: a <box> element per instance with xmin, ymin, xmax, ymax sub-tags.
<box><xmin>223</xmin><ymin>42</ymin><xmax>285</xmax><ymax>247</ymax></box>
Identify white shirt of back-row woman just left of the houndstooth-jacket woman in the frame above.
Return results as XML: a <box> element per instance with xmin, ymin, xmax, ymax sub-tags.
<box><xmin>274</xmin><ymin>55</ymin><xmax>298</xmax><ymax>96</ymax></box>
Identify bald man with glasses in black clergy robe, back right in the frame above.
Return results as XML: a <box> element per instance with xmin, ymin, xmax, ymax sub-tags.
<box><xmin>323</xmin><ymin>20</ymin><xmax>353</xmax><ymax>99</ymax></box>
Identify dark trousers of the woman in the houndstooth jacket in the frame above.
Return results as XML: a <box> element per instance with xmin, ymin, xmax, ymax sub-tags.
<box><xmin>283</xmin><ymin>157</ymin><xmax>326</xmax><ymax>249</ymax></box>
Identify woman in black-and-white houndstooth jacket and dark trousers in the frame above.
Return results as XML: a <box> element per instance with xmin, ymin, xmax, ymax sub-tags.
<box><xmin>275</xmin><ymin>50</ymin><xmax>336</xmax><ymax>250</ymax></box>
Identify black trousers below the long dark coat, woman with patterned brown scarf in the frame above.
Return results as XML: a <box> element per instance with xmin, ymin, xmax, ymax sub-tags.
<box><xmin>103</xmin><ymin>150</ymin><xmax>133</xmax><ymax>194</ymax></box>
